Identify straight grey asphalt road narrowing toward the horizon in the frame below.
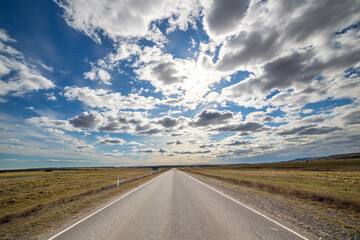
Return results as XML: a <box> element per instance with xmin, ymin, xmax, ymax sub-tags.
<box><xmin>50</xmin><ymin>169</ymin><xmax>306</xmax><ymax>240</ymax></box>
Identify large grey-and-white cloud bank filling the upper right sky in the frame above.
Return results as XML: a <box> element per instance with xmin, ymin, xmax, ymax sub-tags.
<box><xmin>211</xmin><ymin>0</ymin><xmax>360</xmax><ymax>114</ymax></box>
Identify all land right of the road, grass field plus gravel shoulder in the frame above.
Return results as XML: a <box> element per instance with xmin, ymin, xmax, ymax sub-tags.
<box><xmin>181</xmin><ymin>156</ymin><xmax>360</xmax><ymax>239</ymax></box>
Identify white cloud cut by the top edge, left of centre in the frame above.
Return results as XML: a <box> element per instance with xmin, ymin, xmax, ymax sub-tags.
<box><xmin>56</xmin><ymin>0</ymin><xmax>199</xmax><ymax>43</ymax></box>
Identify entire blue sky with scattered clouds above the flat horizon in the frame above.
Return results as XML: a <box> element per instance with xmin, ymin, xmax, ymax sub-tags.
<box><xmin>0</xmin><ymin>0</ymin><xmax>360</xmax><ymax>169</ymax></box>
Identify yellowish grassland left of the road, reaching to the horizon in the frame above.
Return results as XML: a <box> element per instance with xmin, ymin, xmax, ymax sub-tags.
<box><xmin>0</xmin><ymin>168</ymin><xmax>165</xmax><ymax>239</ymax></box>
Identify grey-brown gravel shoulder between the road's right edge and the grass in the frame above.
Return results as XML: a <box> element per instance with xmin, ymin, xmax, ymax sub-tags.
<box><xmin>186</xmin><ymin>172</ymin><xmax>360</xmax><ymax>239</ymax></box>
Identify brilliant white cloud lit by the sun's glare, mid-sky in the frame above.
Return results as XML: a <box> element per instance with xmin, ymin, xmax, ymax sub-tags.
<box><xmin>135</xmin><ymin>47</ymin><xmax>223</xmax><ymax>109</ymax></box>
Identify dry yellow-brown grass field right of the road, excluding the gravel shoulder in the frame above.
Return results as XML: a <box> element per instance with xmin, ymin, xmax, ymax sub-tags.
<box><xmin>184</xmin><ymin>159</ymin><xmax>360</xmax><ymax>212</ymax></box>
